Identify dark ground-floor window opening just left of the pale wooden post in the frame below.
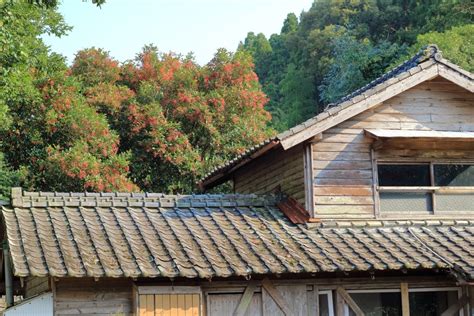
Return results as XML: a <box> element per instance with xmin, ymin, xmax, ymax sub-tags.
<box><xmin>349</xmin><ymin>292</ymin><xmax>400</xmax><ymax>316</ymax></box>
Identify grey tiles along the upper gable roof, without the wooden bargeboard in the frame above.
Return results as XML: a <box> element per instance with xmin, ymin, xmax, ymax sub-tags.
<box><xmin>198</xmin><ymin>45</ymin><xmax>474</xmax><ymax>187</ymax></box>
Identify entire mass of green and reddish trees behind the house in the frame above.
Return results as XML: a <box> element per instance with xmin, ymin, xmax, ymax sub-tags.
<box><xmin>0</xmin><ymin>0</ymin><xmax>474</xmax><ymax>198</ymax></box>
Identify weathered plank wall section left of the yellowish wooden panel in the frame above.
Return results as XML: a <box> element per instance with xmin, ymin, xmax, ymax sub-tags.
<box><xmin>54</xmin><ymin>278</ymin><xmax>133</xmax><ymax>316</ymax></box>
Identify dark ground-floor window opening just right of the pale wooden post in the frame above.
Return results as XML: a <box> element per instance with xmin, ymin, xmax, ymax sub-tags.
<box><xmin>409</xmin><ymin>291</ymin><xmax>458</xmax><ymax>316</ymax></box>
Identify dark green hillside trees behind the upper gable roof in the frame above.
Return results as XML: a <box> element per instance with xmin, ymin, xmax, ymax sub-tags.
<box><xmin>238</xmin><ymin>0</ymin><xmax>474</xmax><ymax>130</ymax></box>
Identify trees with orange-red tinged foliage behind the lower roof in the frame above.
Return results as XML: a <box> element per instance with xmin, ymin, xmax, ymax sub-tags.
<box><xmin>3</xmin><ymin>43</ymin><xmax>271</xmax><ymax>193</ymax></box>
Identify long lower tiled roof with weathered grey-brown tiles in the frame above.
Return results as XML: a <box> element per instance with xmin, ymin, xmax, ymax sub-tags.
<box><xmin>3</xmin><ymin>191</ymin><xmax>474</xmax><ymax>278</ymax></box>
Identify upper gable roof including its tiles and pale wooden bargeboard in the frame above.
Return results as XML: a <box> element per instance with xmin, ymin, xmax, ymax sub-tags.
<box><xmin>198</xmin><ymin>45</ymin><xmax>474</xmax><ymax>189</ymax></box>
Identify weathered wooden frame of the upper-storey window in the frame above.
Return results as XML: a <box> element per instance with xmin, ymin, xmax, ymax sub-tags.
<box><xmin>373</xmin><ymin>159</ymin><xmax>474</xmax><ymax>217</ymax></box>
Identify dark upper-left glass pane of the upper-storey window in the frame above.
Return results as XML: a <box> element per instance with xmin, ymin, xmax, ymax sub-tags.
<box><xmin>377</xmin><ymin>165</ymin><xmax>431</xmax><ymax>187</ymax></box>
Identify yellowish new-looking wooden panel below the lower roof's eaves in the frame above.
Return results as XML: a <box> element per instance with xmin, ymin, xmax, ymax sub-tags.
<box><xmin>136</xmin><ymin>286</ymin><xmax>202</xmax><ymax>316</ymax></box>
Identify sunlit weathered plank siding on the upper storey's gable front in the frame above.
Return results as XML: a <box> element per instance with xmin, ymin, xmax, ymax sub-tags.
<box><xmin>313</xmin><ymin>77</ymin><xmax>474</xmax><ymax>218</ymax></box>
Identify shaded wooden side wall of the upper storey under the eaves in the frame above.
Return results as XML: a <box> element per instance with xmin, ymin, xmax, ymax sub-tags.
<box><xmin>234</xmin><ymin>146</ymin><xmax>305</xmax><ymax>205</ymax></box>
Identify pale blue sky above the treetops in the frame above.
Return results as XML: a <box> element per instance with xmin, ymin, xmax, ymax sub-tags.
<box><xmin>45</xmin><ymin>0</ymin><xmax>312</xmax><ymax>64</ymax></box>
